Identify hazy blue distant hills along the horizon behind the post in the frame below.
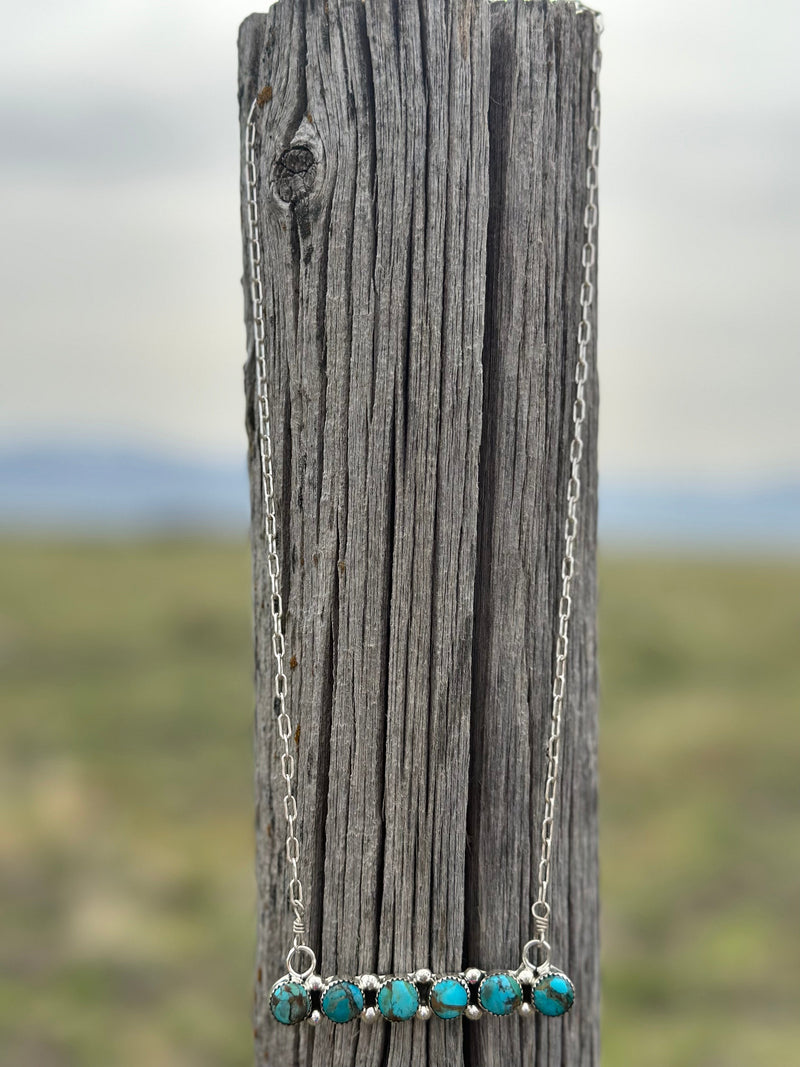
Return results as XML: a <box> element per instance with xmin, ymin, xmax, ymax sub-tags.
<box><xmin>0</xmin><ymin>445</ymin><xmax>800</xmax><ymax>551</ymax></box>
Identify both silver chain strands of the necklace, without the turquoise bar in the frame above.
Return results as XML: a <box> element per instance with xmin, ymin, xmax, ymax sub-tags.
<box><xmin>245</xmin><ymin>3</ymin><xmax>603</xmax><ymax>978</ymax></box>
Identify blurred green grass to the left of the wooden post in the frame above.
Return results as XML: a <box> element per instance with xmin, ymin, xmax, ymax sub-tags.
<box><xmin>0</xmin><ymin>543</ymin><xmax>254</xmax><ymax>1067</ymax></box>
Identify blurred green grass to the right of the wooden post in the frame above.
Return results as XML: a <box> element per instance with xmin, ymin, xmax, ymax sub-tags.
<box><xmin>601</xmin><ymin>559</ymin><xmax>800</xmax><ymax>1067</ymax></box>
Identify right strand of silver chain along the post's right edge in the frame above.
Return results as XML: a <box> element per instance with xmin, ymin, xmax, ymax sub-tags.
<box><xmin>531</xmin><ymin>3</ymin><xmax>603</xmax><ymax>944</ymax></box>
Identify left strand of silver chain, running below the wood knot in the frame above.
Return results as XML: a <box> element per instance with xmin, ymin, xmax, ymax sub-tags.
<box><xmin>245</xmin><ymin>98</ymin><xmax>314</xmax><ymax>973</ymax></box>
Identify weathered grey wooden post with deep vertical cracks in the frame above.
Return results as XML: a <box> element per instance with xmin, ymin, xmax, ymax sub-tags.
<box><xmin>240</xmin><ymin>0</ymin><xmax>598</xmax><ymax>1067</ymax></box>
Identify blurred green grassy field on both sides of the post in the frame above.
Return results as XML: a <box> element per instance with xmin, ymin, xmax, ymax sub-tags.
<box><xmin>0</xmin><ymin>541</ymin><xmax>800</xmax><ymax>1067</ymax></box>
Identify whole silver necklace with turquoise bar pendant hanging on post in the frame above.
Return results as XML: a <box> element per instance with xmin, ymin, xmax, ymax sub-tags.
<box><xmin>244</xmin><ymin>3</ymin><xmax>603</xmax><ymax>1025</ymax></box>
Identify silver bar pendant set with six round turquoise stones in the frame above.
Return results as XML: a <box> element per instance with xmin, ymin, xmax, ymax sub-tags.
<box><xmin>270</xmin><ymin>957</ymin><xmax>575</xmax><ymax>1026</ymax></box>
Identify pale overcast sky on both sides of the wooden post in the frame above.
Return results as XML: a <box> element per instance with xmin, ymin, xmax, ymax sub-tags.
<box><xmin>0</xmin><ymin>0</ymin><xmax>800</xmax><ymax>482</ymax></box>
